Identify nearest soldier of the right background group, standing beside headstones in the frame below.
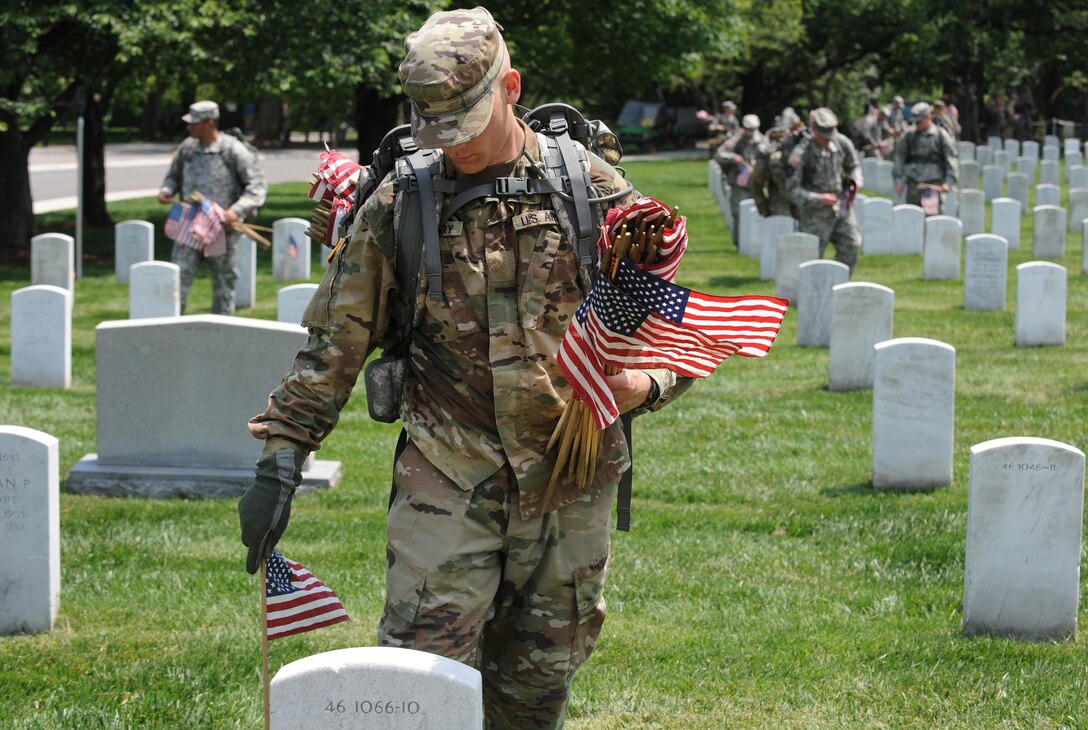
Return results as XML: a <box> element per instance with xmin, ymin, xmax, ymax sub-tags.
<box><xmin>787</xmin><ymin>108</ymin><xmax>862</xmax><ymax>272</ymax></box>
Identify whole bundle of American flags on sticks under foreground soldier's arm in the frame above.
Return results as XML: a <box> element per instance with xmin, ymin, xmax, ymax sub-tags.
<box><xmin>547</xmin><ymin>198</ymin><xmax>789</xmax><ymax>486</ymax></box>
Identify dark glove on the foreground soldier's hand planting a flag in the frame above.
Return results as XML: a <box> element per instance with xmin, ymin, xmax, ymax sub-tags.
<box><xmin>238</xmin><ymin>448</ymin><xmax>309</xmax><ymax>573</ymax></box>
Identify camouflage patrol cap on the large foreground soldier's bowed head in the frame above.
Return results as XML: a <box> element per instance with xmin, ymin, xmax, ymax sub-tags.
<box><xmin>399</xmin><ymin>8</ymin><xmax>506</xmax><ymax>148</ymax></box>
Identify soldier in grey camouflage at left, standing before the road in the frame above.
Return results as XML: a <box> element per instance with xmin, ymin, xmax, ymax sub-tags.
<box><xmin>159</xmin><ymin>101</ymin><xmax>268</xmax><ymax>314</ymax></box>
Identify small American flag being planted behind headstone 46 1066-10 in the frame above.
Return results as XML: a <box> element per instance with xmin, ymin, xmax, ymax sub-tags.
<box><xmin>264</xmin><ymin>550</ymin><xmax>348</xmax><ymax>641</ymax></box>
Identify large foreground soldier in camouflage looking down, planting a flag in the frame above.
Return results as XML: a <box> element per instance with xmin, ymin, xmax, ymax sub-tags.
<box><xmin>238</xmin><ymin>8</ymin><xmax>690</xmax><ymax>728</ymax></box>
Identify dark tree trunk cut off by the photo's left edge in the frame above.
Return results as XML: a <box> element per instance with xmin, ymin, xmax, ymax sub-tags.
<box><xmin>0</xmin><ymin>123</ymin><xmax>34</xmax><ymax>265</ymax></box>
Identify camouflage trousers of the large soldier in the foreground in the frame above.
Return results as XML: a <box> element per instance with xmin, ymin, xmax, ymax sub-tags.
<box><xmin>378</xmin><ymin>445</ymin><xmax>615</xmax><ymax>729</ymax></box>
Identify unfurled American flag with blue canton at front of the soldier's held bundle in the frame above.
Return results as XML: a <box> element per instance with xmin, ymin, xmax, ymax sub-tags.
<box><xmin>558</xmin><ymin>259</ymin><xmax>789</xmax><ymax>429</ymax></box>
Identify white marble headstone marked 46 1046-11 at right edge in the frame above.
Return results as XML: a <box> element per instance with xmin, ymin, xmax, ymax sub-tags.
<box><xmin>963</xmin><ymin>437</ymin><xmax>1085</xmax><ymax>640</ymax></box>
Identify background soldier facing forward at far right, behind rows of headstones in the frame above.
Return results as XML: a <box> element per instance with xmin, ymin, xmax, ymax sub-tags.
<box><xmin>891</xmin><ymin>101</ymin><xmax>959</xmax><ymax>215</ymax></box>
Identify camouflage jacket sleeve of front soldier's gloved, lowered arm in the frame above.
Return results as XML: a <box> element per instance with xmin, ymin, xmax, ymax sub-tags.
<box><xmin>249</xmin><ymin>176</ymin><xmax>397</xmax><ymax>450</ymax></box>
